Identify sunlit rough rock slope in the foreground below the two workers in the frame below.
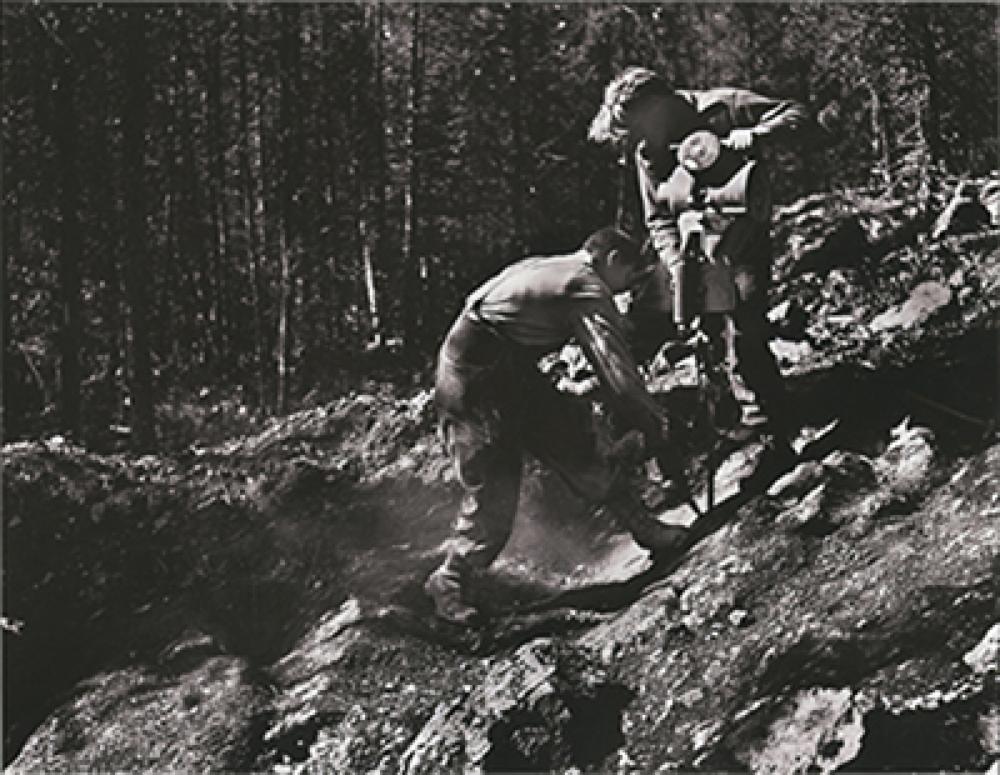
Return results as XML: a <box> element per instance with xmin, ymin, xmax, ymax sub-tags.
<box><xmin>13</xmin><ymin>424</ymin><xmax>1000</xmax><ymax>773</ymax></box>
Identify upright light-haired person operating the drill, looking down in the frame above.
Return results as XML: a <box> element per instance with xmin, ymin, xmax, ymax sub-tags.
<box><xmin>589</xmin><ymin>67</ymin><xmax>815</xmax><ymax>480</ymax></box>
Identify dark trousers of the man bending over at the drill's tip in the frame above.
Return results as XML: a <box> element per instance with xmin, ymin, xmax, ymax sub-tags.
<box><xmin>435</xmin><ymin>352</ymin><xmax>616</xmax><ymax>575</ymax></box>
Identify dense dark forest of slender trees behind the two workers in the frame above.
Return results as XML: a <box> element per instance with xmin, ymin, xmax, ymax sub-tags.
<box><xmin>2</xmin><ymin>2</ymin><xmax>1000</xmax><ymax>451</ymax></box>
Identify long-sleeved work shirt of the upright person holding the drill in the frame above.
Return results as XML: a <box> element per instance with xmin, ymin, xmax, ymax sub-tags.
<box><xmin>635</xmin><ymin>88</ymin><xmax>812</xmax><ymax>266</ymax></box>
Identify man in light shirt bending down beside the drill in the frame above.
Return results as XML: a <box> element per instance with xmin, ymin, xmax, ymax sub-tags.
<box><xmin>424</xmin><ymin>228</ymin><xmax>687</xmax><ymax>623</ymax></box>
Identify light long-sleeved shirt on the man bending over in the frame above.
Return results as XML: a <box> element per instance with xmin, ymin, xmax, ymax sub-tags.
<box><xmin>442</xmin><ymin>251</ymin><xmax>662</xmax><ymax>445</ymax></box>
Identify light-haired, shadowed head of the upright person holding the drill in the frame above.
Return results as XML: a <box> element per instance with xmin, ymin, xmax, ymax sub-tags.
<box><xmin>587</xmin><ymin>67</ymin><xmax>699</xmax><ymax>152</ymax></box>
